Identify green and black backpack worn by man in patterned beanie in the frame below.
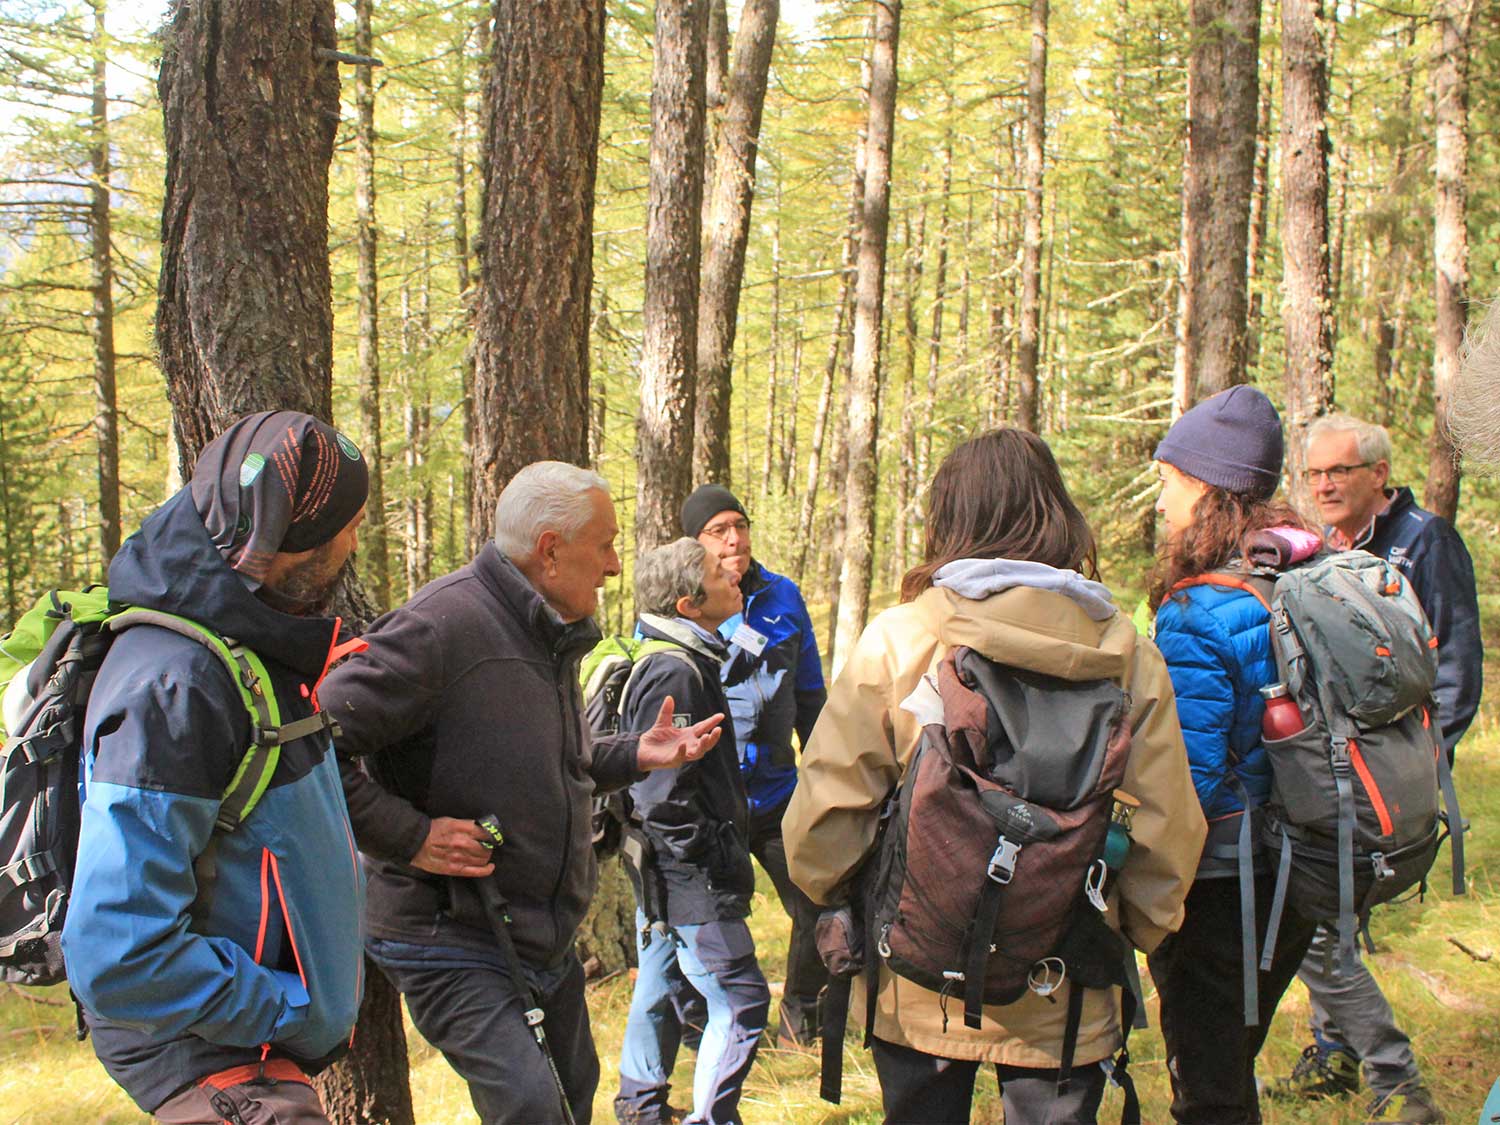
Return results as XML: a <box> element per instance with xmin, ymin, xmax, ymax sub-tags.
<box><xmin>0</xmin><ymin>587</ymin><xmax>336</xmax><ymax>986</ymax></box>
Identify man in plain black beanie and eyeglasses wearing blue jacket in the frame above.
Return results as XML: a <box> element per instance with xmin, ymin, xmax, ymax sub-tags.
<box><xmin>683</xmin><ymin>485</ymin><xmax>828</xmax><ymax>1046</ymax></box>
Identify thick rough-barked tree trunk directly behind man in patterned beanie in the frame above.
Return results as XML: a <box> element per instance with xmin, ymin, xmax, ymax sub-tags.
<box><xmin>156</xmin><ymin>0</ymin><xmax>414</xmax><ymax>1125</ymax></box>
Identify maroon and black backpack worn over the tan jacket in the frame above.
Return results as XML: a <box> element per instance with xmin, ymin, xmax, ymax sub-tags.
<box><xmin>864</xmin><ymin>648</ymin><xmax>1136</xmax><ymax>1110</ymax></box>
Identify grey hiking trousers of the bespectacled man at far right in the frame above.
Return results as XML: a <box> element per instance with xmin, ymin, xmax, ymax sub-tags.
<box><xmin>1298</xmin><ymin>924</ymin><xmax>1422</xmax><ymax>1095</ymax></box>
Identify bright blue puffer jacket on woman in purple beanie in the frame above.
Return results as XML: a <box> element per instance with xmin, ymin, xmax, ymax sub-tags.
<box><xmin>1155</xmin><ymin>585</ymin><xmax>1277</xmax><ymax>834</ymax></box>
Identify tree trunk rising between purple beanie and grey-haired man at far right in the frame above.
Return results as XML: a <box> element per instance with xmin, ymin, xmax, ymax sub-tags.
<box><xmin>1281</xmin><ymin>0</ymin><xmax>1334</xmax><ymax>512</ymax></box>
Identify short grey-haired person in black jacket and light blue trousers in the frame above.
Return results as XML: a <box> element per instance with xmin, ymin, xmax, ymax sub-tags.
<box><xmin>615</xmin><ymin>539</ymin><xmax>771</xmax><ymax>1125</ymax></box>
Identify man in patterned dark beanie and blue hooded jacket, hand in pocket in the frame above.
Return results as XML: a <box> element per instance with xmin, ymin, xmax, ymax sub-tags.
<box><xmin>63</xmin><ymin>411</ymin><xmax>369</xmax><ymax>1125</ymax></box>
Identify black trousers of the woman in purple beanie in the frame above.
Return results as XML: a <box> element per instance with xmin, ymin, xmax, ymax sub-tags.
<box><xmin>1146</xmin><ymin>875</ymin><xmax>1317</xmax><ymax>1125</ymax></box>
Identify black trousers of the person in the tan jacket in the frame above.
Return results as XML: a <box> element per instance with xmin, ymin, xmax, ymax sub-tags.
<box><xmin>872</xmin><ymin>1038</ymin><xmax>1107</xmax><ymax>1125</ymax></box>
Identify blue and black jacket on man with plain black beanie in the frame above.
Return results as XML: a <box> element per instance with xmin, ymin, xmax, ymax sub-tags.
<box><xmin>719</xmin><ymin>560</ymin><xmax>828</xmax><ymax>813</ymax></box>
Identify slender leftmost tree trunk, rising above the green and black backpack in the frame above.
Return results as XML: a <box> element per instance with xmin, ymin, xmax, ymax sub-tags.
<box><xmin>89</xmin><ymin>0</ymin><xmax>120</xmax><ymax>567</ymax></box>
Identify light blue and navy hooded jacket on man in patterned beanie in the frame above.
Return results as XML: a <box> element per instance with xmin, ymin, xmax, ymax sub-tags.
<box><xmin>63</xmin><ymin>489</ymin><xmax>363</xmax><ymax>1112</ymax></box>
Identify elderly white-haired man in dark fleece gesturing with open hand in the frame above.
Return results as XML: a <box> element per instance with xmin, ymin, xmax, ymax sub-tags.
<box><xmin>320</xmin><ymin>462</ymin><xmax>723</xmax><ymax>1125</ymax></box>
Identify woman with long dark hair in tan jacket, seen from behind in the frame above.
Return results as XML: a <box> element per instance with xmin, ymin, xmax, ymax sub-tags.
<box><xmin>785</xmin><ymin>429</ymin><xmax>1205</xmax><ymax>1125</ymax></box>
